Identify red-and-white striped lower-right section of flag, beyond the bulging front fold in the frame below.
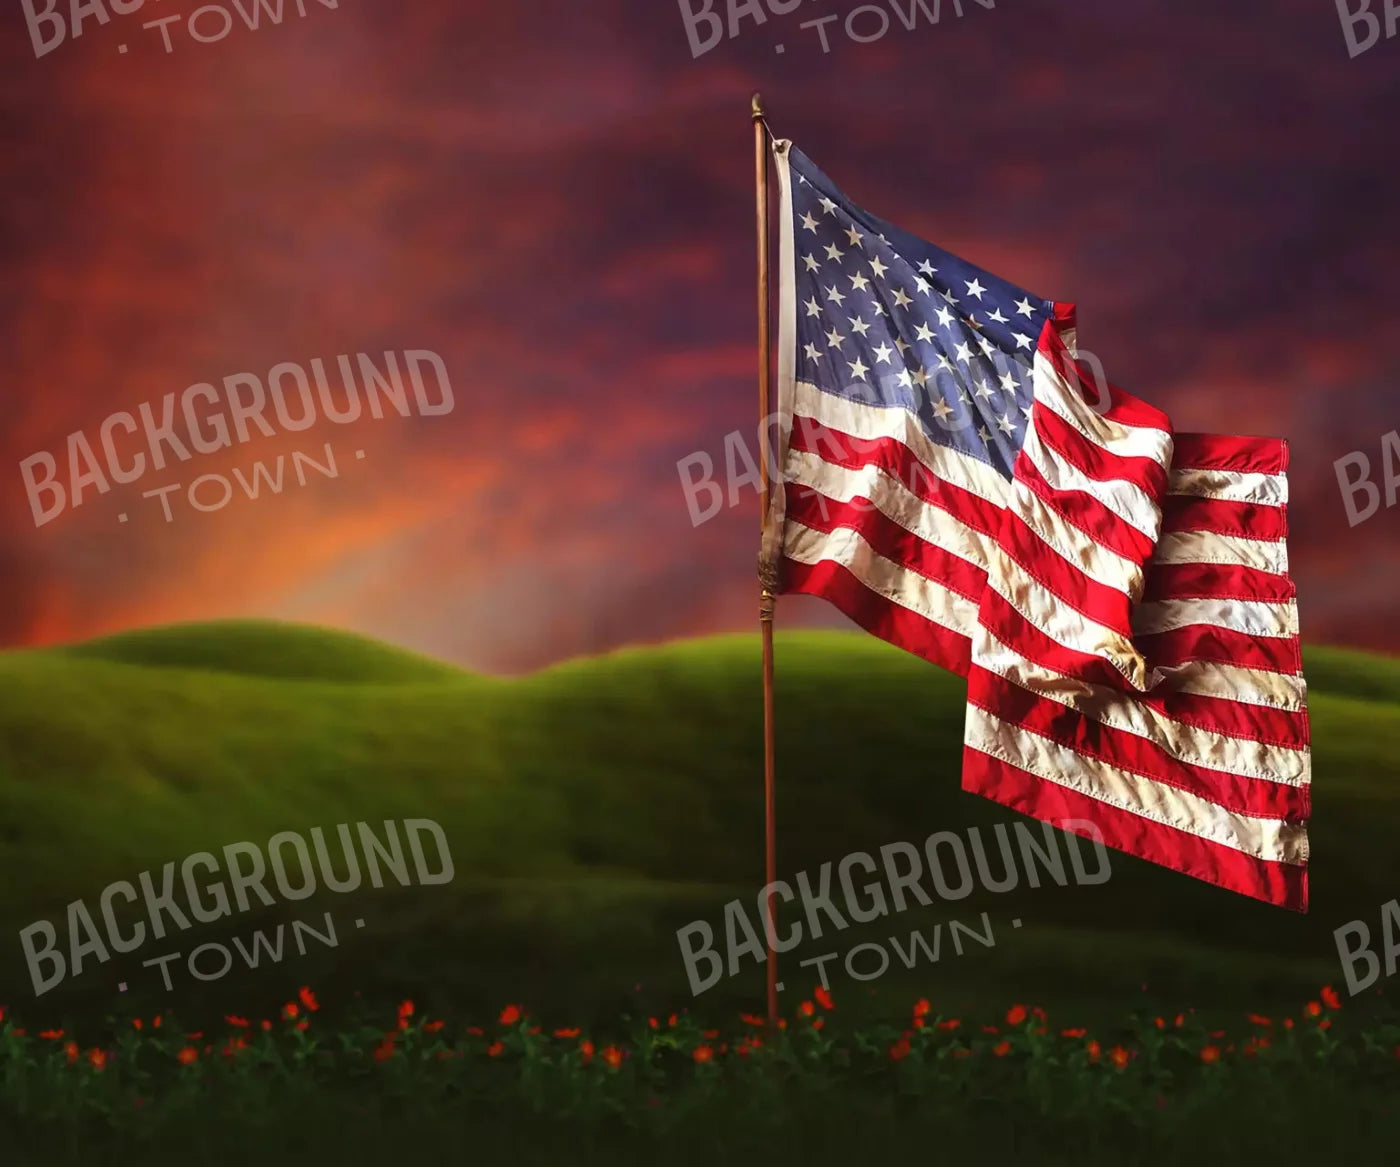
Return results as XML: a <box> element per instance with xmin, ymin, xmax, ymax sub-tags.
<box><xmin>963</xmin><ymin>434</ymin><xmax>1310</xmax><ymax>911</ymax></box>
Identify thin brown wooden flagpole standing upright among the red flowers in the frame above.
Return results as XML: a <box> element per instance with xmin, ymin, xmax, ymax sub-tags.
<box><xmin>752</xmin><ymin>94</ymin><xmax>778</xmax><ymax>1031</ymax></box>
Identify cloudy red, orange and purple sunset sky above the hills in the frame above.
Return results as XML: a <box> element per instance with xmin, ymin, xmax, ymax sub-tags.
<box><xmin>0</xmin><ymin>0</ymin><xmax>1400</xmax><ymax>673</ymax></box>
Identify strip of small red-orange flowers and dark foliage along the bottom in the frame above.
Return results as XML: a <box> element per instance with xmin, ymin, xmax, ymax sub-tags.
<box><xmin>0</xmin><ymin>988</ymin><xmax>1400</xmax><ymax>1163</ymax></box>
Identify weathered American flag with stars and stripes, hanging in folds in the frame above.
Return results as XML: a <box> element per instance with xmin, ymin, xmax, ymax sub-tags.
<box><xmin>763</xmin><ymin>140</ymin><xmax>1310</xmax><ymax>911</ymax></box>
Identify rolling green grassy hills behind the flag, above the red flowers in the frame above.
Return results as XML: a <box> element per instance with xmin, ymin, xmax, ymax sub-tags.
<box><xmin>0</xmin><ymin>621</ymin><xmax>1400</xmax><ymax>1029</ymax></box>
